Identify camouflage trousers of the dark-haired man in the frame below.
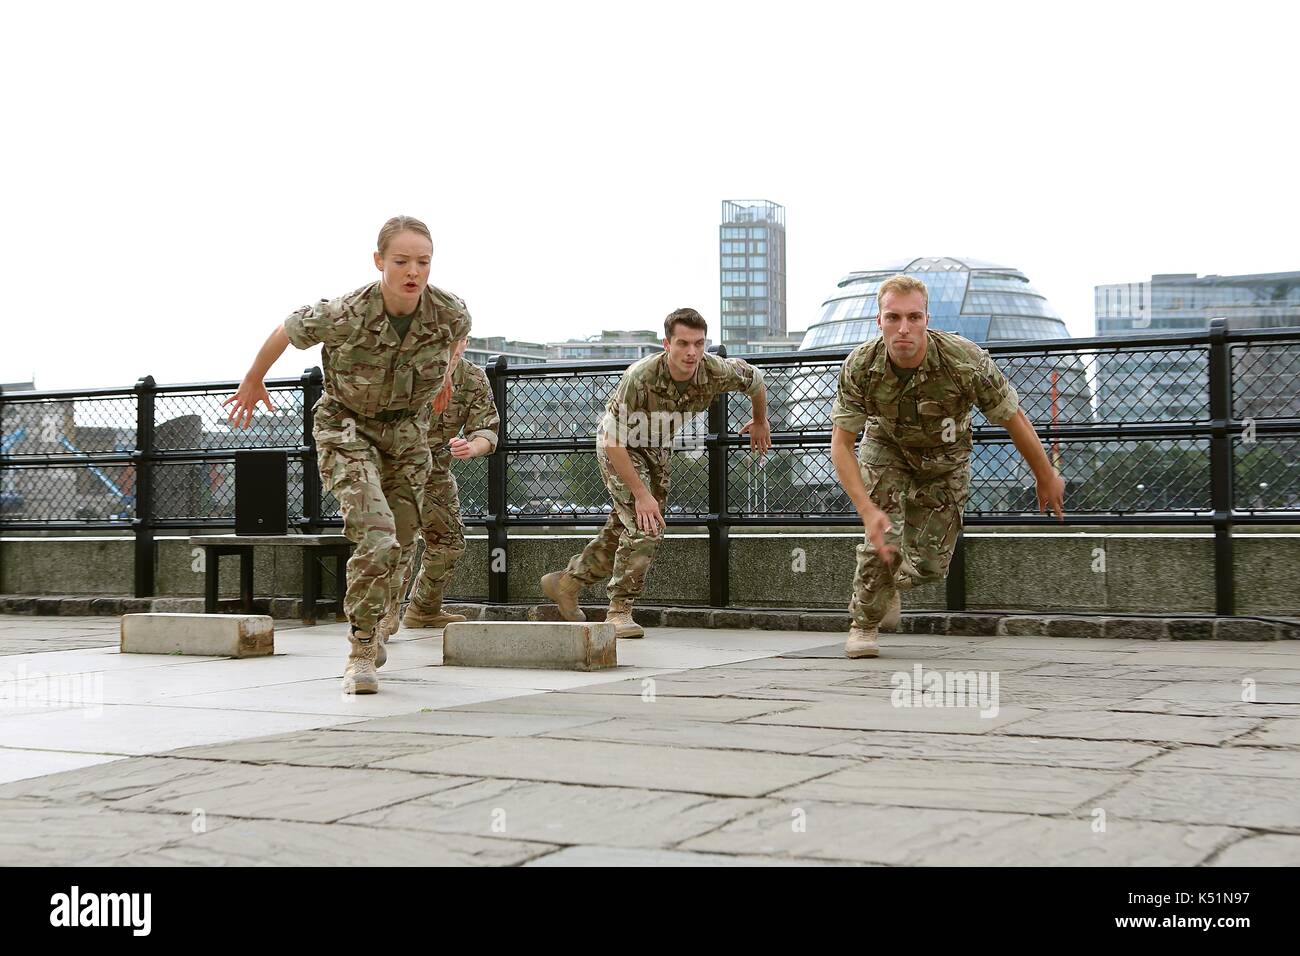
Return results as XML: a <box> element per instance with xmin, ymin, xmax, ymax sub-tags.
<box><xmin>564</xmin><ymin>449</ymin><xmax>671</xmax><ymax>602</ymax></box>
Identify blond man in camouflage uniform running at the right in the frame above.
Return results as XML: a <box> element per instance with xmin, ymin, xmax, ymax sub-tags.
<box><xmin>831</xmin><ymin>276</ymin><xmax>1065</xmax><ymax>657</ymax></box>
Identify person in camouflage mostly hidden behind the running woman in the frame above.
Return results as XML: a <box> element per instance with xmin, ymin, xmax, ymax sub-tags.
<box><xmin>391</xmin><ymin>342</ymin><xmax>501</xmax><ymax>630</ymax></box>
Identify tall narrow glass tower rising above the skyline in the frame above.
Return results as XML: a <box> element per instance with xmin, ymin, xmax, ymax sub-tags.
<box><xmin>718</xmin><ymin>199</ymin><xmax>788</xmax><ymax>355</ymax></box>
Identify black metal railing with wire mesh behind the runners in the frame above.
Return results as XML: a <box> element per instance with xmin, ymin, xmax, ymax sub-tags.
<box><xmin>0</xmin><ymin>320</ymin><xmax>1300</xmax><ymax>614</ymax></box>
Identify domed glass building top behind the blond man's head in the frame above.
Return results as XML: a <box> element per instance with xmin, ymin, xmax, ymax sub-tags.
<box><xmin>800</xmin><ymin>256</ymin><xmax>1070</xmax><ymax>351</ymax></box>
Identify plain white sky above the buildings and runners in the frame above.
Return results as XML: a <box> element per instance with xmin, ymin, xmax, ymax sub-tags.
<box><xmin>0</xmin><ymin>0</ymin><xmax>1300</xmax><ymax>389</ymax></box>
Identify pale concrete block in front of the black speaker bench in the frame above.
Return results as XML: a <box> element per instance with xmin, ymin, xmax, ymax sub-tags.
<box><xmin>121</xmin><ymin>614</ymin><xmax>276</xmax><ymax>657</ymax></box>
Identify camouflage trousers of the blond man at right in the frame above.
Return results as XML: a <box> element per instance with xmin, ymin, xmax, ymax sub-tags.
<box><xmin>849</xmin><ymin>438</ymin><xmax>971</xmax><ymax>627</ymax></box>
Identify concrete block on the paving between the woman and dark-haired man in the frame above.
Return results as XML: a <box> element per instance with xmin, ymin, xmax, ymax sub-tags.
<box><xmin>442</xmin><ymin>620</ymin><xmax>618</xmax><ymax>671</ymax></box>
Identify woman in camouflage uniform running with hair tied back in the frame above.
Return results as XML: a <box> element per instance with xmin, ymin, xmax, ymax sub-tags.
<box><xmin>225</xmin><ymin>216</ymin><xmax>469</xmax><ymax>693</ymax></box>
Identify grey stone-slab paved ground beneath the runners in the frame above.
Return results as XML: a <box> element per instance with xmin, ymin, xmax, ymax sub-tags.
<box><xmin>0</xmin><ymin>617</ymin><xmax>1300</xmax><ymax>866</ymax></box>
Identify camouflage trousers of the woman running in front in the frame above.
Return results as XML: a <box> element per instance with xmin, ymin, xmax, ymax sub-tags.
<box><xmin>312</xmin><ymin>395</ymin><xmax>429</xmax><ymax>631</ymax></box>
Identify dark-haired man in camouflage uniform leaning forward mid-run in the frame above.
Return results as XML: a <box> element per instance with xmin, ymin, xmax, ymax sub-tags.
<box><xmin>542</xmin><ymin>308</ymin><xmax>772</xmax><ymax>637</ymax></box>
